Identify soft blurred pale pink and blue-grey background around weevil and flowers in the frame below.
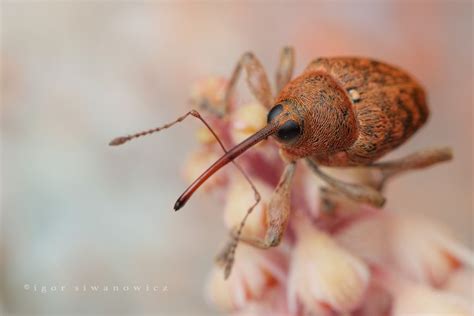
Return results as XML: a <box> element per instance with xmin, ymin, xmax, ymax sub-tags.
<box><xmin>0</xmin><ymin>1</ymin><xmax>474</xmax><ymax>315</ymax></box>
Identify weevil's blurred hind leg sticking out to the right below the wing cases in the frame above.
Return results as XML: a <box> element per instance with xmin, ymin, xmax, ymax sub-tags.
<box><xmin>368</xmin><ymin>147</ymin><xmax>453</xmax><ymax>191</ymax></box>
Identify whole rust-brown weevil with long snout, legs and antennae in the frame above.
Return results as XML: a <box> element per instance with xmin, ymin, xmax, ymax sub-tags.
<box><xmin>110</xmin><ymin>47</ymin><xmax>452</xmax><ymax>277</ymax></box>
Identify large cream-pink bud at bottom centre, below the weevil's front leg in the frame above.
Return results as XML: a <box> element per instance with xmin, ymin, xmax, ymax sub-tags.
<box><xmin>288</xmin><ymin>222</ymin><xmax>370</xmax><ymax>312</ymax></box>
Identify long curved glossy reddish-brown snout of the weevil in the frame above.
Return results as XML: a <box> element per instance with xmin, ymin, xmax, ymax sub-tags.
<box><xmin>174</xmin><ymin>123</ymin><xmax>278</xmax><ymax>211</ymax></box>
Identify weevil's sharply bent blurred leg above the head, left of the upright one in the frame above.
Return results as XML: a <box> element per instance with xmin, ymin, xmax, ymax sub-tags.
<box><xmin>224</xmin><ymin>52</ymin><xmax>273</xmax><ymax>111</ymax></box>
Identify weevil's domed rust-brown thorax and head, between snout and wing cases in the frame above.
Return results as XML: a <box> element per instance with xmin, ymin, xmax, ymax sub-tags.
<box><xmin>268</xmin><ymin>71</ymin><xmax>358</xmax><ymax>160</ymax></box>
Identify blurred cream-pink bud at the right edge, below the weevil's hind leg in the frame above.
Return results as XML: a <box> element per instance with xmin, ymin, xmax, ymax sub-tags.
<box><xmin>336</xmin><ymin>212</ymin><xmax>474</xmax><ymax>286</ymax></box>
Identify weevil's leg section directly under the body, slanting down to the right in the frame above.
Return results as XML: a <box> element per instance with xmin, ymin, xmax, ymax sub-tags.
<box><xmin>306</xmin><ymin>159</ymin><xmax>385</xmax><ymax>207</ymax></box>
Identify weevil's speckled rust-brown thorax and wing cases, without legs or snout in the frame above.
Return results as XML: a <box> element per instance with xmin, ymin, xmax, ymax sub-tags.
<box><xmin>276</xmin><ymin>58</ymin><xmax>429</xmax><ymax>167</ymax></box>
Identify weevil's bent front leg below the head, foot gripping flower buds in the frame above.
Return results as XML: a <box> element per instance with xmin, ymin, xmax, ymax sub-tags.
<box><xmin>216</xmin><ymin>162</ymin><xmax>296</xmax><ymax>278</ymax></box>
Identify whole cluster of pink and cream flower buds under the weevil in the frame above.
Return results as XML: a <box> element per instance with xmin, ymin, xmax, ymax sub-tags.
<box><xmin>185</xmin><ymin>79</ymin><xmax>474</xmax><ymax>316</ymax></box>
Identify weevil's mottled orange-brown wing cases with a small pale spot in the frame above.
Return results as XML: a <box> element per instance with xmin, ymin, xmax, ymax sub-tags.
<box><xmin>305</xmin><ymin>58</ymin><xmax>429</xmax><ymax>166</ymax></box>
